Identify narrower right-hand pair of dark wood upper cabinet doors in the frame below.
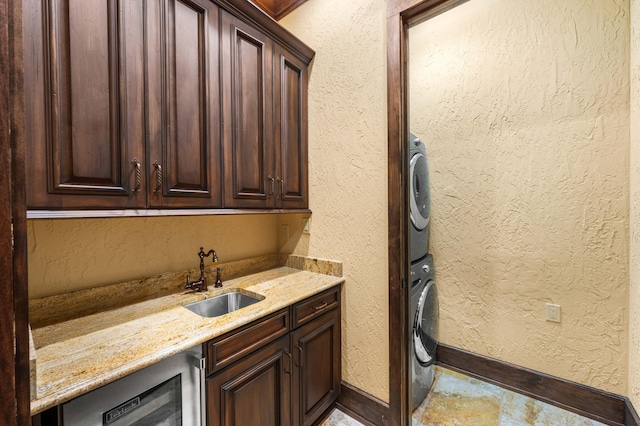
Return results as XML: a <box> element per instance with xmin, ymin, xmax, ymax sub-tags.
<box><xmin>221</xmin><ymin>12</ymin><xmax>308</xmax><ymax>208</ymax></box>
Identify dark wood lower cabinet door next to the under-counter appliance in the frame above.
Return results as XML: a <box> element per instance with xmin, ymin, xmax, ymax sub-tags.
<box><xmin>207</xmin><ymin>336</ymin><xmax>291</xmax><ymax>426</ymax></box>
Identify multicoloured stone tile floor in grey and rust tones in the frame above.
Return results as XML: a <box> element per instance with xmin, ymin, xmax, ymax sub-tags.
<box><xmin>321</xmin><ymin>367</ymin><xmax>604</xmax><ymax>426</ymax></box>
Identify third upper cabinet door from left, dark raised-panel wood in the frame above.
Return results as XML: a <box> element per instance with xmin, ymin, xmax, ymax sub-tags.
<box><xmin>221</xmin><ymin>12</ymin><xmax>276</xmax><ymax>208</ymax></box>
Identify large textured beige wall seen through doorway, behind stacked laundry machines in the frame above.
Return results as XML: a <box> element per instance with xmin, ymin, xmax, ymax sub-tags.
<box><xmin>410</xmin><ymin>0</ymin><xmax>638</xmax><ymax>394</ymax></box>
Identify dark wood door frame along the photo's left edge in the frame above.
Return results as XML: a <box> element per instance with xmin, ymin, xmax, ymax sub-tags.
<box><xmin>0</xmin><ymin>0</ymin><xmax>31</xmax><ymax>425</ymax></box>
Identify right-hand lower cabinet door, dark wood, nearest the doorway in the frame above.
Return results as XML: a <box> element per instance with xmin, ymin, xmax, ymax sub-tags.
<box><xmin>291</xmin><ymin>309</ymin><xmax>341</xmax><ymax>426</ymax></box>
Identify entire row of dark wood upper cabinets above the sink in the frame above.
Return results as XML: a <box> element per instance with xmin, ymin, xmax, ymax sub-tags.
<box><xmin>24</xmin><ymin>0</ymin><xmax>313</xmax><ymax>211</ymax></box>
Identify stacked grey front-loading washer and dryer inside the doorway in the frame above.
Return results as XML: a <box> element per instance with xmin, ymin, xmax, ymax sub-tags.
<box><xmin>409</xmin><ymin>134</ymin><xmax>438</xmax><ymax>408</ymax></box>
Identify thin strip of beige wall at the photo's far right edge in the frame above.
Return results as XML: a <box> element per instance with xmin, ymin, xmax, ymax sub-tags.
<box><xmin>628</xmin><ymin>0</ymin><xmax>640</xmax><ymax>410</ymax></box>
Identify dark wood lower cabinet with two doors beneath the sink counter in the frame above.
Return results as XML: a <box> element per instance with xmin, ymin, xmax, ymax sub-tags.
<box><xmin>205</xmin><ymin>286</ymin><xmax>341</xmax><ymax>426</ymax></box>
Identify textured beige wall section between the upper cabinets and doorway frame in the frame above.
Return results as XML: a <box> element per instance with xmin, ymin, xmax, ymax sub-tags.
<box><xmin>281</xmin><ymin>0</ymin><xmax>389</xmax><ymax>401</ymax></box>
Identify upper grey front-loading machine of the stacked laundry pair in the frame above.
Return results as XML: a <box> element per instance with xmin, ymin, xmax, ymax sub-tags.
<box><xmin>409</xmin><ymin>133</ymin><xmax>431</xmax><ymax>263</ymax></box>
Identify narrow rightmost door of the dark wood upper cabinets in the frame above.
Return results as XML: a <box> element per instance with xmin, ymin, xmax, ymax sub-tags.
<box><xmin>274</xmin><ymin>45</ymin><xmax>309</xmax><ymax>208</ymax></box>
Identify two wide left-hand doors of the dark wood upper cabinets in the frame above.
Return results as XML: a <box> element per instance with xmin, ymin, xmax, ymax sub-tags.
<box><xmin>25</xmin><ymin>0</ymin><xmax>221</xmax><ymax>209</ymax></box>
